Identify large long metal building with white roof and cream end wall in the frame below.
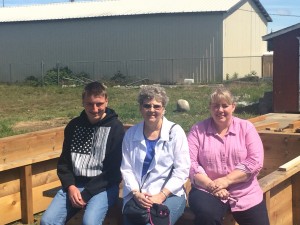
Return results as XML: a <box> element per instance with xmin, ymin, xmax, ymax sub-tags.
<box><xmin>0</xmin><ymin>0</ymin><xmax>272</xmax><ymax>83</ymax></box>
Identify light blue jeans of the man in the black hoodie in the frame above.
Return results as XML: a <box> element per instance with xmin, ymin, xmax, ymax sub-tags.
<box><xmin>40</xmin><ymin>185</ymin><xmax>119</xmax><ymax>225</ymax></box>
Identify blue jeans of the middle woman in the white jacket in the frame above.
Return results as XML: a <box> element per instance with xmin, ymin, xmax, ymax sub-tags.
<box><xmin>123</xmin><ymin>195</ymin><xmax>186</xmax><ymax>225</ymax></box>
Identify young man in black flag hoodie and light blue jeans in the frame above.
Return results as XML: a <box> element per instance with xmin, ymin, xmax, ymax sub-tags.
<box><xmin>41</xmin><ymin>82</ymin><xmax>124</xmax><ymax>225</ymax></box>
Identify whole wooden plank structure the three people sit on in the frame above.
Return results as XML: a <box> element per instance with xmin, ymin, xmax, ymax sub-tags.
<box><xmin>0</xmin><ymin>115</ymin><xmax>300</xmax><ymax>225</ymax></box>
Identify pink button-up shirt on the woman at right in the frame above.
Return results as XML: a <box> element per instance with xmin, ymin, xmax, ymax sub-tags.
<box><xmin>188</xmin><ymin>117</ymin><xmax>264</xmax><ymax>211</ymax></box>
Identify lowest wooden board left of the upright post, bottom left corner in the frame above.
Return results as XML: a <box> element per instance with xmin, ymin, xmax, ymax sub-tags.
<box><xmin>0</xmin><ymin>193</ymin><xmax>21</xmax><ymax>224</ymax></box>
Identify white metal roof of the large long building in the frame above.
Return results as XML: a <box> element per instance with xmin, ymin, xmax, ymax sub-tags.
<box><xmin>0</xmin><ymin>0</ymin><xmax>266</xmax><ymax>22</ymax></box>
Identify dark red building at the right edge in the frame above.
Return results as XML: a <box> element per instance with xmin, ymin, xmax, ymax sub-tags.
<box><xmin>263</xmin><ymin>23</ymin><xmax>300</xmax><ymax>113</ymax></box>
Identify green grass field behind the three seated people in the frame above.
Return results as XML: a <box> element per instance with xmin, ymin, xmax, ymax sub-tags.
<box><xmin>0</xmin><ymin>79</ymin><xmax>272</xmax><ymax>137</ymax></box>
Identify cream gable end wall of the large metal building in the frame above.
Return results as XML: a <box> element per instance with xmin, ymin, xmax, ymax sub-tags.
<box><xmin>223</xmin><ymin>2</ymin><xmax>267</xmax><ymax>79</ymax></box>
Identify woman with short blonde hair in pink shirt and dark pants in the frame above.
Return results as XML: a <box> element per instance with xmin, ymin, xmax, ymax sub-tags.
<box><xmin>188</xmin><ymin>88</ymin><xmax>269</xmax><ymax>225</ymax></box>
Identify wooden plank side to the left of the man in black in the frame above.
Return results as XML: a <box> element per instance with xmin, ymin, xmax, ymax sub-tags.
<box><xmin>0</xmin><ymin>125</ymin><xmax>131</xmax><ymax>224</ymax></box>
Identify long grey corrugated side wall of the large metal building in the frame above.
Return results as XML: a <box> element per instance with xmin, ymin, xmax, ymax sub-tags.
<box><xmin>0</xmin><ymin>14</ymin><xmax>222</xmax><ymax>83</ymax></box>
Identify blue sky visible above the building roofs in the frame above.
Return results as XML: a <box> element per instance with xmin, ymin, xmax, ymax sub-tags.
<box><xmin>0</xmin><ymin>0</ymin><xmax>300</xmax><ymax>33</ymax></box>
